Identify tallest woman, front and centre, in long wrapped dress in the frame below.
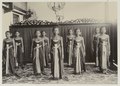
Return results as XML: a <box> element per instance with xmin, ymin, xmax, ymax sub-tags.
<box><xmin>51</xmin><ymin>27</ymin><xmax>64</xmax><ymax>79</ymax></box>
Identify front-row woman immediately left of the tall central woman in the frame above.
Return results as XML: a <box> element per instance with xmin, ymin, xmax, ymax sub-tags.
<box><xmin>31</xmin><ymin>30</ymin><xmax>44</xmax><ymax>76</ymax></box>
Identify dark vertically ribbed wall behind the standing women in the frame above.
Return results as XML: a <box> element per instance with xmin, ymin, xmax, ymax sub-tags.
<box><xmin>10</xmin><ymin>23</ymin><xmax>117</xmax><ymax>63</ymax></box>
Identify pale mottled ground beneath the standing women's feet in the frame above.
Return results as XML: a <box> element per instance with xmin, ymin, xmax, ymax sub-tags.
<box><xmin>3</xmin><ymin>64</ymin><xmax>117</xmax><ymax>84</ymax></box>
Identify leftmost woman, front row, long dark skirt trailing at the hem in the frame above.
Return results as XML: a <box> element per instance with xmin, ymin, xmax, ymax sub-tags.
<box><xmin>3</xmin><ymin>31</ymin><xmax>20</xmax><ymax>78</ymax></box>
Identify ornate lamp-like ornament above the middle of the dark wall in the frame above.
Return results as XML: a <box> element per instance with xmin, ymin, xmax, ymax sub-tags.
<box><xmin>47</xmin><ymin>2</ymin><xmax>65</xmax><ymax>22</ymax></box>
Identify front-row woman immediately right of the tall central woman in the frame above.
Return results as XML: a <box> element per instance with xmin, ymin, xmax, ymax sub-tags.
<box><xmin>74</xmin><ymin>29</ymin><xmax>85</xmax><ymax>74</ymax></box>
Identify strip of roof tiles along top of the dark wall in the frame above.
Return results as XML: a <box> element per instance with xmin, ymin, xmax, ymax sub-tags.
<box><xmin>11</xmin><ymin>18</ymin><xmax>100</xmax><ymax>26</ymax></box>
